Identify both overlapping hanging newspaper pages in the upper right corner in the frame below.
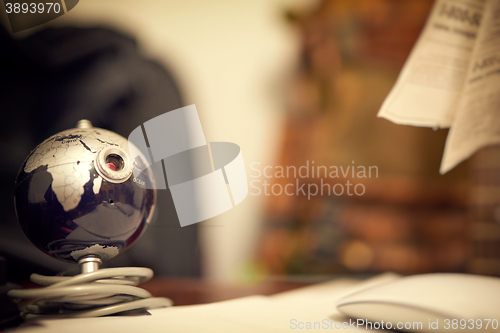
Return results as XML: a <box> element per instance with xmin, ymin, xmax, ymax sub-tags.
<box><xmin>378</xmin><ymin>0</ymin><xmax>500</xmax><ymax>174</ymax></box>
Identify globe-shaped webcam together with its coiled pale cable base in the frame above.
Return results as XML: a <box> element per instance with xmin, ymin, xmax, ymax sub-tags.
<box><xmin>9</xmin><ymin>120</ymin><xmax>171</xmax><ymax>319</ymax></box>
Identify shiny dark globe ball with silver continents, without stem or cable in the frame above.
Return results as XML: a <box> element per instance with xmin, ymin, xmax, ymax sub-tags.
<box><xmin>14</xmin><ymin>121</ymin><xmax>156</xmax><ymax>262</ymax></box>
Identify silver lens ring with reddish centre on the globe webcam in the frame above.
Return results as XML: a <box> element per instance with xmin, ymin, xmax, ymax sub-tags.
<box><xmin>96</xmin><ymin>146</ymin><xmax>132</xmax><ymax>183</ymax></box>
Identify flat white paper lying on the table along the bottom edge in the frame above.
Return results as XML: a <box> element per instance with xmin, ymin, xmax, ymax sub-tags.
<box><xmin>17</xmin><ymin>274</ymin><xmax>398</xmax><ymax>333</ymax></box>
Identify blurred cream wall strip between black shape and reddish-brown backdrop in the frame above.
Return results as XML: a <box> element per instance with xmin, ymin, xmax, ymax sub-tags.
<box><xmin>56</xmin><ymin>0</ymin><xmax>311</xmax><ymax>281</ymax></box>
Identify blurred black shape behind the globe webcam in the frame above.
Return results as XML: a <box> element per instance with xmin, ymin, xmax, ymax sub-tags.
<box><xmin>0</xmin><ymin>27</ymin><xmax>200</xmax><ymax>279</ymax></box>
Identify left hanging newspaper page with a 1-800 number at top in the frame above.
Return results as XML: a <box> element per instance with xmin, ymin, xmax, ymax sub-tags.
<box><xmin>378</xmin><ymin>0</ymin><xmax>485</xmax><ymax>128</ymax></box>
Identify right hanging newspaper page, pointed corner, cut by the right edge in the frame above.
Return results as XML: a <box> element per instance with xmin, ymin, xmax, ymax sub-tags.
<box><xmin>440</xmin><ymin>0</ymin><xmax>500</xmax><ymax>174</ymax></box>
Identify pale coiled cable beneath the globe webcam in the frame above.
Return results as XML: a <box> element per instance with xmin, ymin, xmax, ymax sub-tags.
<box><xmin>8</xmin><ymin>267</ymin><xmax>172</xmax><ymax>320</ymax></box>
